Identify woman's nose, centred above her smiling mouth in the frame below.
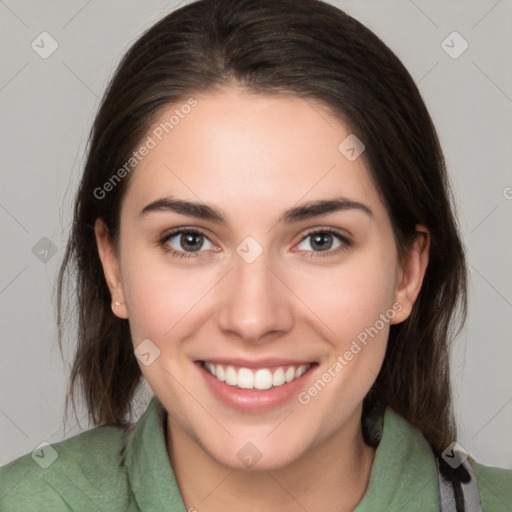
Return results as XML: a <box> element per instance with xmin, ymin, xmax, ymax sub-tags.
<box><xmin>217</xmin><ymin>252</ymin><xmax>294</xmax><ymax>344</ymax></box>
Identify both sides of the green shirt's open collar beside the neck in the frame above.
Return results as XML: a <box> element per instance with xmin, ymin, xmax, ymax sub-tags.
<box><xmin>124</xmin><ymin>396</ymin><xmax>438</xmax><ymax>512</ymax></box>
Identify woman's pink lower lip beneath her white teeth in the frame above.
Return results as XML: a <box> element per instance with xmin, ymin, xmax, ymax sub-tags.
<box><xmin>196</xmin><ymin>362</ymin><xmax>317</xmax><ymax>413</ymax></box>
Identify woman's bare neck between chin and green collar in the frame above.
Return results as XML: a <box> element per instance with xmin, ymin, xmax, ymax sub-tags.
<box><xmin>167</xmin><ymin>414</ymin><xmax>375</xmax><ymax>512</ymax></box>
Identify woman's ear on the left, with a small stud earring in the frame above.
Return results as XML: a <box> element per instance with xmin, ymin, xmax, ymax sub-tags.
<box><xmin>94</xmin><ymin>218</ymin><xmax>128</xmax><ymax>319</ymax></box>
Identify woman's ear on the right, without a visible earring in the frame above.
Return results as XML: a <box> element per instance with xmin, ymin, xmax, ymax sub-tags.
<box><xmin>391</xmin><ymin>224</ymin><xmax>430</xmax><ymax>324</ymax></box>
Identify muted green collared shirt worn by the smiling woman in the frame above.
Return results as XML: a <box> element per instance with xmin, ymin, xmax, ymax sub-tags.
<box><xmin>0</xmin><ymin>396</ymin><xmax>512</xmax><ymax>512</ymax></box>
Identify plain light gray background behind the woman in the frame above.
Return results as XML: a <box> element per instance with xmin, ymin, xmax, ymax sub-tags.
<box><xmin>0</xmin><ymin>0</ymin><xmax>512</xmax><ymax>469</ymax></box>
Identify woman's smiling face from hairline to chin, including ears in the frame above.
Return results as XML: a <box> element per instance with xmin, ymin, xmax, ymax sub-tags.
<box><xmin>96</xmin><ymin>88</ymin><xmax>428</xmax><ymax>468</ymax></box>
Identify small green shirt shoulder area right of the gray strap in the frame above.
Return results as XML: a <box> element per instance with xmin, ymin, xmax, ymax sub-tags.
<box><xmin>471</xmin><ymin>459</ymin><xmax>512</xmax><ymax>512</ymax></box>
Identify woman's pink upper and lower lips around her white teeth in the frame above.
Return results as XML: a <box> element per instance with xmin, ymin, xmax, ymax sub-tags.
<box><xmin>195</xmin><ymin>359</ymin><xmax>318</xmax><ymax>413</ymax></box>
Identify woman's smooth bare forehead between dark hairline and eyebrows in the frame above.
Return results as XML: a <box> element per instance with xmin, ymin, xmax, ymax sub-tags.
<box><xmin>121</xmin><ymin>88</ymin><xmax>382</xmax><ymax>220</ymax></box>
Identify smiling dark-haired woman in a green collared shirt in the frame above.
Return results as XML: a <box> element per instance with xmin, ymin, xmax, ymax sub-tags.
<box><xmin>0</xmin><ymin>0</ymin><xmax>512</xmax><ymax>512</ymax></box>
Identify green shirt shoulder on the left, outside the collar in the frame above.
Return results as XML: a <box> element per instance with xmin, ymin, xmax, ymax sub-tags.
<box><xmin>0</xmin><ymin>426</ymin><xmax>134</xmax><ymax>512</ymax></box>
